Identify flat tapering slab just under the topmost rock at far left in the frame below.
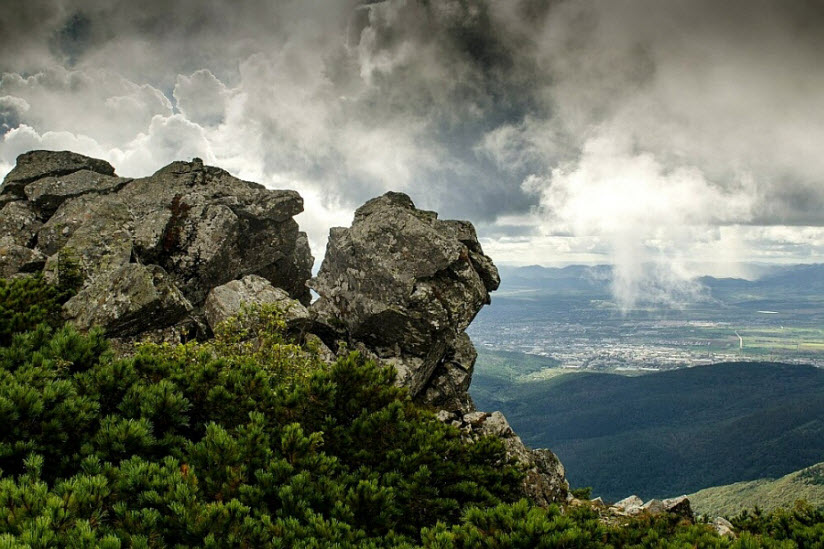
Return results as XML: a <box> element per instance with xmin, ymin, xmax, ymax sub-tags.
<box><xmin>24</xmin><ymin>170</ymin><xmax>131</xmax><ymax>215</ymax></box>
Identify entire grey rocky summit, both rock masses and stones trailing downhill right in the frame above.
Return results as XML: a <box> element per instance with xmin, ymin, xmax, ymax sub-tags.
<box><xmin>0</xmin><ymin>151</ymin><xmax>569</xmax><ymax>505</ymax></box>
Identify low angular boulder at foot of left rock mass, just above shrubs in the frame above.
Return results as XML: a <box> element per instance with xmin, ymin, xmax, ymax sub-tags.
<box><xmin>63</xmin><ymin>263</ymin><xmax>192</xmax><ymax>337</ymax></box>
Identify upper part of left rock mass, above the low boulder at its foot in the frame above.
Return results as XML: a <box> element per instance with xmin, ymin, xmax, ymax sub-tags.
<box><xmin>0</xmin><ymin>151</ymin><xmax>313</xmax><ymax>318</ymax></box>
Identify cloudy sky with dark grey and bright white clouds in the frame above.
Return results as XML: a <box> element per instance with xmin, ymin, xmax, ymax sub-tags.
<box><xmin>0</xmin><ymin>0</ymin><xmax>824</xmax><ymax>303</ymax></box>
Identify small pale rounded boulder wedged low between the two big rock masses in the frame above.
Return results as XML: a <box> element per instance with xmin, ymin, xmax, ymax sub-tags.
<box><xmin>203</xmin><ymin>275</ymin><xmax>310</xmax><ymax>330</ymax></box>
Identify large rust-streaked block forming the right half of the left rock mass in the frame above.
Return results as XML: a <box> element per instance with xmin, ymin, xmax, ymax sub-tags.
<box><xmin>120</xmin><ymin>159</ymin><xmax>313</xmax><ymax>304</ymax></box>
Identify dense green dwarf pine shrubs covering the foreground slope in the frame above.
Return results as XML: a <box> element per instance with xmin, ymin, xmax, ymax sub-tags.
<box><xmin>0</xmin><ymin>278</ymin><xmax>824</xmax><ymax>549</ymax></box>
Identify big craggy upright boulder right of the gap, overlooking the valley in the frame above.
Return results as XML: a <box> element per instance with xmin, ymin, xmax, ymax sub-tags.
<box><xmin>309</xmin><ymin>192</ymin><xmax>500</xmax><ymax>410</ymax></box>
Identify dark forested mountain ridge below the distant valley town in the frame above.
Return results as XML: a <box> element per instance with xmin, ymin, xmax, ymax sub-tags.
<box><xmin>472</xmin><ymin>354</ymin><xmax>824</xmax><ymax>500</ymax></box>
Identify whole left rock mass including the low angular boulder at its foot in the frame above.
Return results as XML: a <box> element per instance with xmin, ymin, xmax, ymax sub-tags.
<box><xmin>0</xmin><ymin>151</ymin><xmax>313</xmax><ymax>337</ymax></box>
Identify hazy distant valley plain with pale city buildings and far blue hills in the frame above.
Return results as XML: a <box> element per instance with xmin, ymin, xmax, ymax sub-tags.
<box><xmin>469</xmin><ymin>265</ymin><xmax>824</xmax><ymax>376</ymax></box>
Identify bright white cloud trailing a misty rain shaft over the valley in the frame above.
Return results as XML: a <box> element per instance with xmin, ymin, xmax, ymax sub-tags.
<box><xmin>524</xmin><ymin>131</ymin><xmax>753</xmax><ymax>309</ymax></box>
